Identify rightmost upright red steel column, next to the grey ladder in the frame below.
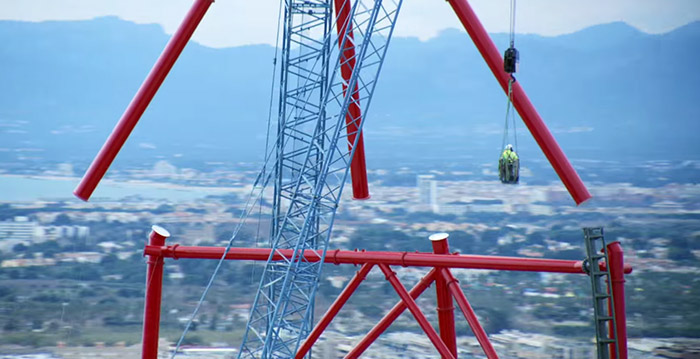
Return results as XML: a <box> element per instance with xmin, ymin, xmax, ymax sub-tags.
<box><xmin>608</xmin><ymin>242</ymin><xmax>627</xmax><ymax>359</ymax></box>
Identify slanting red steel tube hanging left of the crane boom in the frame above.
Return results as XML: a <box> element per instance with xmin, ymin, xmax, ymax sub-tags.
<box><xmin>73</xmin><ymin>0</ymin><xmax>214</xmax><ymax>201</ymax></box>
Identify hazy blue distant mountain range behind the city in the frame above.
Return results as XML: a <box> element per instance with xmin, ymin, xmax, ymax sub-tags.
<box><xmin>0</xmin><ymin>17</ymin><xmax>700</xmax><ymax>170</ymax></box>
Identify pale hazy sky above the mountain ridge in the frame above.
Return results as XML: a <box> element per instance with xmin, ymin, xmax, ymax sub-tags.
<box><xmin>0</xmin><ymin>0</ymin><xmax>700</xmax><ymax>47</ymax></box>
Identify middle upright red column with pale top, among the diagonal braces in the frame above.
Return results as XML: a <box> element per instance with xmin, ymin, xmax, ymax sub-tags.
<box><xmin>429</xmin><ymin>233</ymin><xmax>457</xmax><ymax>358</ymax></box>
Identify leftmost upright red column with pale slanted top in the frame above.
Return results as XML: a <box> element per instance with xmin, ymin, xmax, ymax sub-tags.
<box><xmin>141</xmin><ymin>226</ymin><xmax>170</xmax><ymax>359</ymax></box>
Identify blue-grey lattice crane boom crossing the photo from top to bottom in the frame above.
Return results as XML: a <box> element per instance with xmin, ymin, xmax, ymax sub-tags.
<box><xmin>239</xmin><ymin>0</ymin><xmax>401</xmax><ymax>358</ymax></box>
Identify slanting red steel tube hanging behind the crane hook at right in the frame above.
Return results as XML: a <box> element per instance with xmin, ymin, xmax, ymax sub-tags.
<box><xmin>448</xmin><ymin>0</ymin><xmax>591</xmax><ymax>204</ymax></box>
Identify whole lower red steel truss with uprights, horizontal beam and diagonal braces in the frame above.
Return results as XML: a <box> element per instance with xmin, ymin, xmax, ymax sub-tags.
<box><xmin>143</xmin><ymin>228</ymin><xmax>632</xmax><ymax>359</ymax></box>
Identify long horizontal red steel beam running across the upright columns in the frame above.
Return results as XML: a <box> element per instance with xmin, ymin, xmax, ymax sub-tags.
<box><xmin>144</xmin><ymin>245</ymin><xmax>632</xmax><ymax>274</ymax></box>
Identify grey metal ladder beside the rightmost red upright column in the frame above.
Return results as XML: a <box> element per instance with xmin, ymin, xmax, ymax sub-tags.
<box><xmin>583</xmin><ymin>227</ymin><xmax>620</xmax><ymax>359</ymax></box>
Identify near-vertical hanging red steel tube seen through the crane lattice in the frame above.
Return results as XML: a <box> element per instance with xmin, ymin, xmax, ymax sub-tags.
<box><xmin>335</xmin><ymin>0</ymin><xmax>369</xmax><ymax>199</ymax></box>
